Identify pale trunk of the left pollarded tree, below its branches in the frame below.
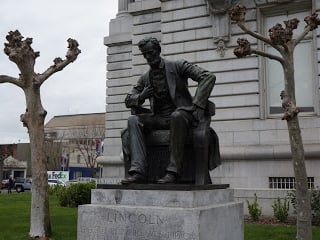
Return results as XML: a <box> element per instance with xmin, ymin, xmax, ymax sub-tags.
<box><xmin>22</xmin><ymin>86</ymin><xmax>51</xmax><ymax>237</ymax></box>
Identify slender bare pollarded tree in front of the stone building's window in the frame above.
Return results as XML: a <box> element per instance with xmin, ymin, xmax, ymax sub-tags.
<box><xmin>230</xmin><ymin>5</ymin><xmax>320</xmax><ymax>240</ymax></box>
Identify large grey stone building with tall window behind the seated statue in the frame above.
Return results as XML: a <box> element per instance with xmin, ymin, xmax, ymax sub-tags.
<box><xmin>99</xmin><ymin>0</ymin><xmax>320</xmax><ymax>199</ymax></box>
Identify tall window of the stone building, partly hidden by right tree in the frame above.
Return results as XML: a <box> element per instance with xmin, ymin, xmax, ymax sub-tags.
<box><xmin>264</xmin><ymin>8</ymin><xmax>317</xmax><ymax>114</ymax></box>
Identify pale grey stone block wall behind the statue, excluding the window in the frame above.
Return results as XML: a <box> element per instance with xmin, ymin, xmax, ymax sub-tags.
<box><xmin>100</xmin><ymin>0</ymin><xmax>320</xmax><ymax>191</ymax></box>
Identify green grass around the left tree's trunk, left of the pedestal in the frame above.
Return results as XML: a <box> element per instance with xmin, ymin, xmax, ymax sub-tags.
<box><xmin>0</xmin><ymin>192</ymin><xmax>78</xmax><ymax>240</ymax></box>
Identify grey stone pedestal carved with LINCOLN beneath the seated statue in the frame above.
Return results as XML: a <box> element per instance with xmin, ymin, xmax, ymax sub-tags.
<box><xmin>78</xmin><ymin>185</ymin><xmax>244</xmax><ymax>240</ymax></box>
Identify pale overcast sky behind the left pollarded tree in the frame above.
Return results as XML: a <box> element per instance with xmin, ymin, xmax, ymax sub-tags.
<box><xmin>0</xmin><ymin>0</ymin><xmax>118</xmax><ymax>144</ymax></box>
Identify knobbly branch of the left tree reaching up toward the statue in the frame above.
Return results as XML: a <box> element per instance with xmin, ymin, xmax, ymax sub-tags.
<box><xmin>34</xmin><ymin>38</ymin><xmax>81</xmax><ymax>86</ymax></box>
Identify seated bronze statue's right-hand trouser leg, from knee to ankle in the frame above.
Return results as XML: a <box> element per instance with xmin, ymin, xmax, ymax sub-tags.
<box><xmin>166</xmin><ymin>110</ymin><xmax>194</xmax><ymax>175</ymax></box>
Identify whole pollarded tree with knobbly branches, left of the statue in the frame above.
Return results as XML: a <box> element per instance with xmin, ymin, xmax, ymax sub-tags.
<box><xmin>0</xmin><ymin>30</ymin><xmax>81</xmax><ymax>239</ymax></box>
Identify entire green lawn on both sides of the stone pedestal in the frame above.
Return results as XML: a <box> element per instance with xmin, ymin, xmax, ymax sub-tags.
<box><xmin>0</xmin><ymin>192</ymin><xmax>320</xmax><ymax>240</ymax></box>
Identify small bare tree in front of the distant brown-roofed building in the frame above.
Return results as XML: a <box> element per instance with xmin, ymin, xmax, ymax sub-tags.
<box><xmin>69</xmin><ymin>126</ymin><xmax>104</xmax><ymax>176</ymax></box>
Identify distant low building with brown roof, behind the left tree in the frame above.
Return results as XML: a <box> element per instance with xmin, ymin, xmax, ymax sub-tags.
<box><xmin>45</xmin><ymin>113</ymin><xmax>105</xmax><ymax>179</ymax></box>
